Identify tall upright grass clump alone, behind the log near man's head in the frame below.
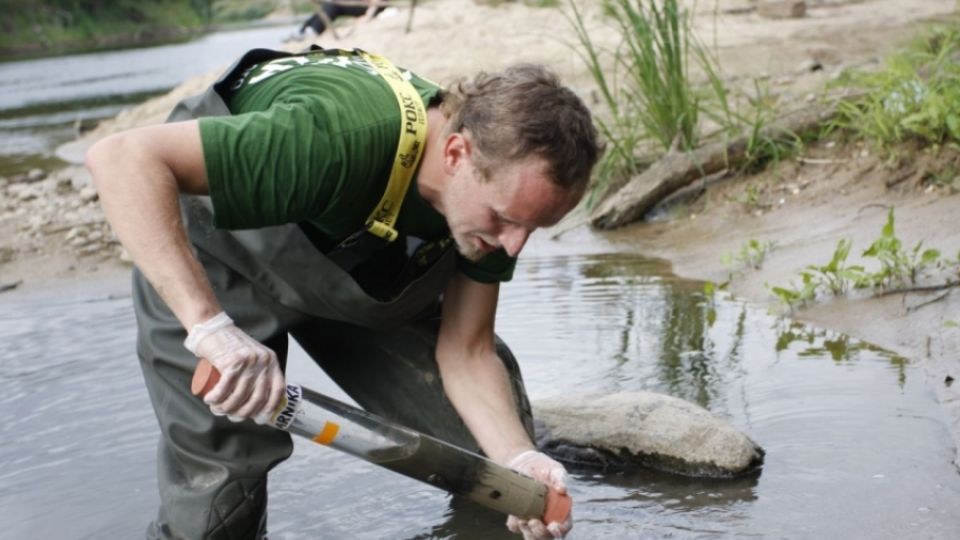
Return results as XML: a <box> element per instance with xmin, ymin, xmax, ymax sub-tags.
<box><xmin>568</xmin><ymin>0</ymin><xmax>741</xmax><ymax>202</ymax></box>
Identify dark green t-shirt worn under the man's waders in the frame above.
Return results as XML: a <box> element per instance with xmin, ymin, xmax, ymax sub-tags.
<box><xmin>193</xmin><ymin>52</ymin><xmax>516</xmax><ymax>283</ymax></box>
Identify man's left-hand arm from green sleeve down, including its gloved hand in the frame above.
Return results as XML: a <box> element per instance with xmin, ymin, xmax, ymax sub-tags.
<box><xmin>87</xmin><ymin>121</ymin><xmax>285</xmax><ymax>421</ymax></box>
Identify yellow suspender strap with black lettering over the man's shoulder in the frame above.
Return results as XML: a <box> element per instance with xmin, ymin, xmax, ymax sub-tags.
<box><xmin>354</xmin><ymin>49</ymin><xmax>427</xmax><ymax>242</ymax></box>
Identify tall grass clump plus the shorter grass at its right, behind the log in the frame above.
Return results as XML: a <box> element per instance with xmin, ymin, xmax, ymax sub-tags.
<box><xmin>568</xmin><ymin>0</ymin><xmax>802</xmax><ymax>206</ymax></box>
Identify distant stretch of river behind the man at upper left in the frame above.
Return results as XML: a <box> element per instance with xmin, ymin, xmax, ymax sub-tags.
<box><xmin>0</xmin><ymin>27</ymin><xmax>291</xmax><ymax>175</ymax></box>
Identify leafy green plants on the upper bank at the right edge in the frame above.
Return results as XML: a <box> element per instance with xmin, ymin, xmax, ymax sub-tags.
<box><xmin>835</xmin><ymin>21</ymin><xmax>960</xmax><ymax>150</ymax></box>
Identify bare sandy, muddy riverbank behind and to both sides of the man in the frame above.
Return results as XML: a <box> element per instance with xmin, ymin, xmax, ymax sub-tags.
<box><xmin>0</xmin><ymin>0</ymin><xmax>960</xmax><ymax>464</ymax></box>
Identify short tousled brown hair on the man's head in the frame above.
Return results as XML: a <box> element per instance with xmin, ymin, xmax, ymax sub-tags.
<box><xmin>440</xmin><ymin>64</ymin><xmax>602</xmax><ymax>191</ymax></box>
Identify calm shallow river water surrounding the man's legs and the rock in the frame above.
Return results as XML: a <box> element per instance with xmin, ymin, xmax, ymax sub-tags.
<box><xmin>0</xmin><ymin>255</ymin><xmax>960</xmax><ymax>539</ymax></box>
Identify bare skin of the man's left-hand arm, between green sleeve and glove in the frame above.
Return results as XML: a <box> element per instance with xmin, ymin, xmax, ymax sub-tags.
<box><xmin>86</xmin><ymin>121</ymin><xmax>221</xmax><ymax>329</ymax></box>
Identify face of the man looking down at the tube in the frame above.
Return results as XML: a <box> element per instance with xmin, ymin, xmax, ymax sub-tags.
<box><xmin>443</xmin><ymin>157</ymin><xmax>580</xmax><ymax>261</ymax></box>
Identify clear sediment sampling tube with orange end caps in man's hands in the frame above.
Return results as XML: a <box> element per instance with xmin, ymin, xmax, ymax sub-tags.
<box><xmin>190</xmin><ymin>359</ymin><xmax>572</xmax><ymax>523</ymax></box>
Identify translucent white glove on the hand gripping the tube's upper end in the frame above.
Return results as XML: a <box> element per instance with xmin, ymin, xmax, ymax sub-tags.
<box><xmin>183</xmin><ymin>312</ymin><xmax>286</xmax><ymax>423</ymax></box>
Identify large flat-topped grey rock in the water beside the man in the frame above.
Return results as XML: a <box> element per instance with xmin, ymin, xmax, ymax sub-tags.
<box><xmin>533</xmin><ymin>392</ymin><xmax>764</xmax><ymax>477</ymax></box>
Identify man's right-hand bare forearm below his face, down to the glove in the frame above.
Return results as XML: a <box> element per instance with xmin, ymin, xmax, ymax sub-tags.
<box><xmin>437</xmin><ymin>273</ymin><xmax>533</xmax><ymax>463</ymax></box>
